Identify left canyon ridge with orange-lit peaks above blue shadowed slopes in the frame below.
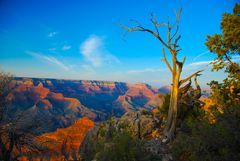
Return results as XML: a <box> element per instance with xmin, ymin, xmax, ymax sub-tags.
<box><xmin>8</xmin><ymin>79</ymin><xmax>97</xmax><ymax>132</ymax></box>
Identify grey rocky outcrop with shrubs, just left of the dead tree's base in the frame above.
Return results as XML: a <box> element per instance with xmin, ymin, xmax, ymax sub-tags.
<box><xmin>80</xmin><ymin>110</ymin><xmax>167</xmax><ymax>161</ymax></box>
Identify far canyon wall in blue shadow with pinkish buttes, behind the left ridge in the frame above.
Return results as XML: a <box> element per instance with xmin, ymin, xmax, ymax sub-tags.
<box><xmin>16</xmin><ymin>78</ymin><xmax>162</xmax><ymax>119</ymax></box>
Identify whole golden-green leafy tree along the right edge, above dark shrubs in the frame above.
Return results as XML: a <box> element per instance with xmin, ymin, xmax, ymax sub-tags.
<box><xmin>205</xmin><ymin>4</ymin><xmax>240</xmax><ymax>107</ymax></box>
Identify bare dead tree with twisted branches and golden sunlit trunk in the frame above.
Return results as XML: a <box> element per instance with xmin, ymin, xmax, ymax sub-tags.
<box><xmin>121</xmin><ymin>8</ymin><xmax>202</xmax><ymax>142</ymax></box>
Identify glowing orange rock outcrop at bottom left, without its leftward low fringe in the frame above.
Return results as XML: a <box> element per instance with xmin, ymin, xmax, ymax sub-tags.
<box><xmin>38</xmin><ymin>117</ymin><xmax>94</xmax><ymax>160</ymax></box>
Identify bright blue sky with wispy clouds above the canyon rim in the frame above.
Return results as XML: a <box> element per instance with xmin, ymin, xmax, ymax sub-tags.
<box><xmin>0</xmin><ymin>0</ymin><xmax>237</xmax><ymax>87</ymax></box>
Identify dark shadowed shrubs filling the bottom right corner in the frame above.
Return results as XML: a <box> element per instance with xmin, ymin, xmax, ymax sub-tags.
<box><xmin>173</xmin><ymin>106</ymin><xmax>240</xmax><ymax>161</ymax></box>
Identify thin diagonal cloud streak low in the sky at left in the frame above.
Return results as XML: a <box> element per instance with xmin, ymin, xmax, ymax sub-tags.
<box><xmin>26</xmin><ymin>51</ymin><xmax>71</xmax><ymax>71</ymax></box>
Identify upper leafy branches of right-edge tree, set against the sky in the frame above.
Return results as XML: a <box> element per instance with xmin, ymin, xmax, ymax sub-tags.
<box><xmin>205</xmin><ymin>4</ymin><xmax>240</xmax><ymax>75</ymax></box>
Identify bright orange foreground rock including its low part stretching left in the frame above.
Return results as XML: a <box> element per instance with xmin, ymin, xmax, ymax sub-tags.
<box><xmin>18</xmin><ymin>117</ymin><xmax>94</xmax><ymax>161</ymax></box>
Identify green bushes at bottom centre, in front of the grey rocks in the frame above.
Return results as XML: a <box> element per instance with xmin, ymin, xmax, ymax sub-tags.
<box><xmin>80</xmin><ymin>118</ymin><xmax>162</xmax><ymax>161</ymax></box>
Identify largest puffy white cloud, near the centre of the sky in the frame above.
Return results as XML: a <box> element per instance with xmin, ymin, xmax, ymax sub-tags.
<box><xmin>80</xmin><ymin>35</ymin><xmax>120</xmax><ymax>67</ymax></box>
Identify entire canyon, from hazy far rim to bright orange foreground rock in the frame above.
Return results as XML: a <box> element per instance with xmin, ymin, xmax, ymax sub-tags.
<box><xmin>7</xmin><ymin>77</ymin><xmax>169</xmax><ymax>160</ymax></box>
